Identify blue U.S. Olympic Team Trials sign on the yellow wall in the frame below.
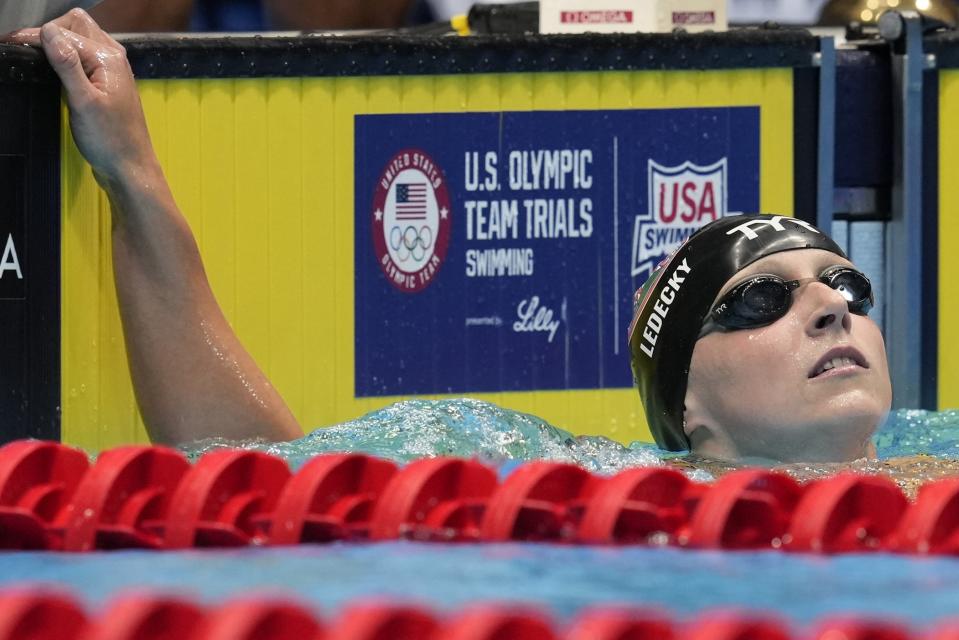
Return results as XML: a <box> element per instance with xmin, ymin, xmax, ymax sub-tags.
<box><xmin>354</xmin><ymin>107</ymin><xmax>759</xmax><ymax>397</ymax></box>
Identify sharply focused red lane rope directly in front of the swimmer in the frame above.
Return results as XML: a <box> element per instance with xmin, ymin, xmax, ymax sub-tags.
<box><xmin>0</xmin><ymin>441</ymin><xmax>959</xmax><ymax>554</ymax></box>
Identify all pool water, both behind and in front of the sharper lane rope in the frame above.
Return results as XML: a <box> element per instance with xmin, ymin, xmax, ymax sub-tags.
<box><xmin>0</xmin><ymin>400</ymin><xmax>959</xmax><ymax>628</ymax></box>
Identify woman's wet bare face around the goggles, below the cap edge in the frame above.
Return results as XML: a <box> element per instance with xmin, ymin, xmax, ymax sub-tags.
<box><xmin>686</xmin><ymin>249</ymin><xmax>892</xmax><ymax>462</ymax></box>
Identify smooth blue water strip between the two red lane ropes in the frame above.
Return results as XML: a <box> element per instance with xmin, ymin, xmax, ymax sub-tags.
<box><xmin>0</xmin><ymin>542</ymin><xmax>959</xmax><ymax>626</ymax></box>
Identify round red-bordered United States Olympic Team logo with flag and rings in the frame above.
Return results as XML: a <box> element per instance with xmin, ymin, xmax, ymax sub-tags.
<box><xmin>373</xmin><ymin>149</ymin><xmax>451</xmax><ymax>293</ymax></box>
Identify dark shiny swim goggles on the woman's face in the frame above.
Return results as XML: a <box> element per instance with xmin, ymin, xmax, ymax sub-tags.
<box><xmin>699</xmin><ymin>266</ymin><xmax>875</xmax><ymax>337</ymax></box>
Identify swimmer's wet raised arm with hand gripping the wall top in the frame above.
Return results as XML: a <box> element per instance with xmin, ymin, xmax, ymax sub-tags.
<box><xmin>15</xmin><ymin>9</ymin><xmax>303</xmax><ymax>444</ymax></box>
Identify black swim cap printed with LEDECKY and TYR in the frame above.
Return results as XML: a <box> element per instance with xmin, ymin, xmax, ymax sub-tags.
<box><xmin>629</xmin><ymin>215</ymin><xmax>846</xmax><ymax>451</ymax></box>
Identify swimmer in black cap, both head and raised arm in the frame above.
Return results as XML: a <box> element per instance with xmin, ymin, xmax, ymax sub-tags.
<box><xmin>13</xmin><ymin>9</ymin><xmax>891</xmax><ymax>462</ymax></box>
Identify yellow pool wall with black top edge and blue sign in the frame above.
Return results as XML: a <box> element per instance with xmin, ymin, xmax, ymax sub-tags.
<box><xmin>56</xmin><ymin>31</ymin><xmax>819</xmax><ymax>449</ymax></box>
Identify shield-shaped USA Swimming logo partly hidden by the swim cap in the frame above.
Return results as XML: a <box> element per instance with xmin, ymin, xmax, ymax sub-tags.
<box><xmin>630</xmin><ymin>158</ymin><xmax>731</xmax><ymax>279</ymax></box>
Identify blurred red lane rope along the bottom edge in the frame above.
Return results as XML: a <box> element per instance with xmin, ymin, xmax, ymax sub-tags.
<box><xmin>0</xmin><ymin>589</ymin><xmax>936</xmax><ymax>640</ymax></box>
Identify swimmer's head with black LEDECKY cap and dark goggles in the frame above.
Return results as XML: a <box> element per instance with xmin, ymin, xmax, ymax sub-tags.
<box><xmin>629</xmin><ymin>216</ymin><xmax>892</xmax><ymax>462</ymax></box>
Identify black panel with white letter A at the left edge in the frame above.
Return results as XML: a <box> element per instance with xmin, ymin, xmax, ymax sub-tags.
<box><xmin>0</xmin><ymin>47</ymin><xmax>60</xmax><ymax>441</ymax></box>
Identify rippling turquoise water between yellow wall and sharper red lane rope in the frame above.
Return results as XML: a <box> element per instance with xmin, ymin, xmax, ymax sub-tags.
<box><xmin>186</xmin><ymin>398</ymin><xmax>959</xmax><ymax>493</ymax></box>
